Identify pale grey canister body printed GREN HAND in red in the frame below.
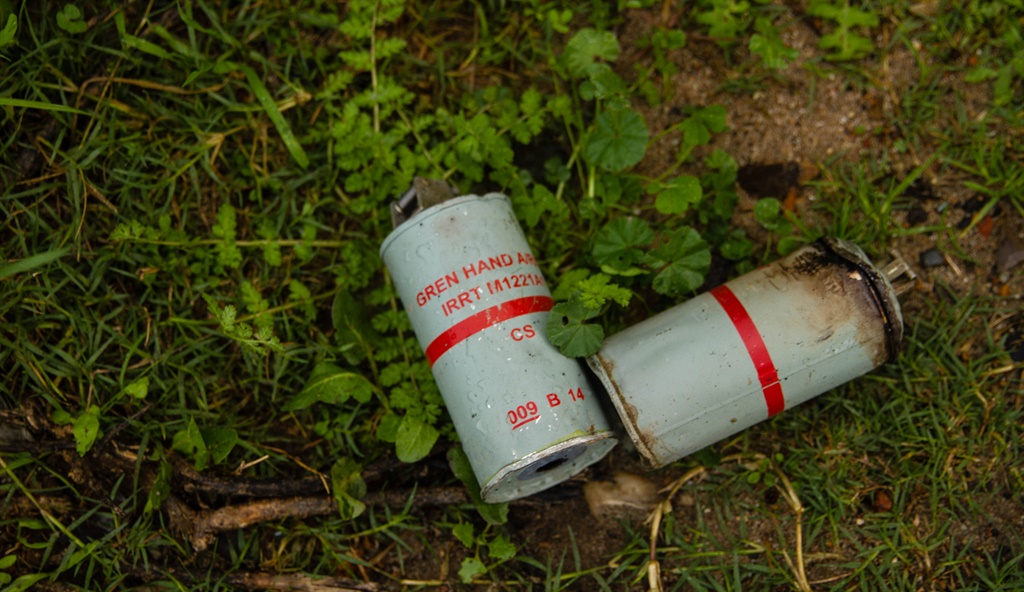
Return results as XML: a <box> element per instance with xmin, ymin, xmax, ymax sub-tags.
<box><xmin>381</xmin><ymin>194</ymin><xmax>615</xmax><ymax>502</ymax></box>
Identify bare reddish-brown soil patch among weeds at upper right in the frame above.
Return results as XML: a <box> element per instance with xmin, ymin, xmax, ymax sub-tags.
<box><xmin>620</xmin><ymin>3</ymin><xmax>1024</xmax><ymax>297</ymax></box>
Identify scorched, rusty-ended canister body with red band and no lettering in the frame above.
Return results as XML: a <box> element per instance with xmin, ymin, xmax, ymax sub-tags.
<box><xmin>588</xmin><ymin>239</ymin><xmax>903</xmax><ymax>467</ymax></box>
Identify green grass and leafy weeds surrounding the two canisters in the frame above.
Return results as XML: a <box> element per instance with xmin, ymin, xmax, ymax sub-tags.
<box><xmin>0</xmin><ymin>0</ymin><xmax>1024</xmax><ymax>590</ymax></box>
